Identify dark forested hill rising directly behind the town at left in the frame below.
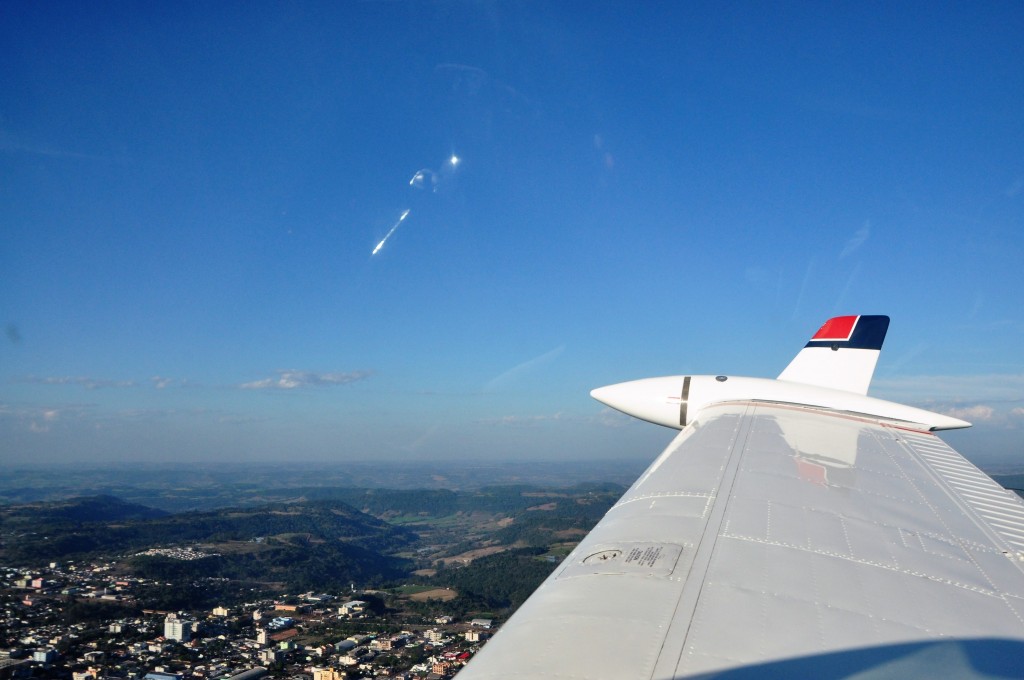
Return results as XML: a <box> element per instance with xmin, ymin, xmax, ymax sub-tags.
<box><xmin>0</xmin><ymin>497</ymin><xmax>416</xmax><ymax>581</ymax></box>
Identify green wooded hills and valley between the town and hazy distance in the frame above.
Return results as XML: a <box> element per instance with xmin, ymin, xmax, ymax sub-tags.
<box><xmin>0</xmin><ymin>483</ymin><xmax>624</xmax><ymax>614</ymax></box>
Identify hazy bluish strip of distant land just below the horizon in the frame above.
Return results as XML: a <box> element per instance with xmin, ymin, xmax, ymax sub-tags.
<box><xmin>0</xmin><ymin>459</ymin><xmax>647</xmax><ymax>512</ymax></box>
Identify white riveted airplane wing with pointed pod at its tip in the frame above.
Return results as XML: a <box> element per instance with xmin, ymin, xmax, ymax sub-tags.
<box><xmin>459</xmin><ymin>317</ymin><xmax>1024</xmax><ymax>680</ymax></box>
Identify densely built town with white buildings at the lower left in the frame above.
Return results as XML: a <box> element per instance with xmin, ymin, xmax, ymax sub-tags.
<box><xmin>0</xmin><ymin>563</ymin><xmax>485</xmax><ymax>680</ymax></box>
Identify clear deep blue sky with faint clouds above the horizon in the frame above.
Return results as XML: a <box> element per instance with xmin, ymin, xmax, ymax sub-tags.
<box><xmin>0</xmin><ymin>1</ymin><xmax>1024</xmax><ymax>465</ymax></box>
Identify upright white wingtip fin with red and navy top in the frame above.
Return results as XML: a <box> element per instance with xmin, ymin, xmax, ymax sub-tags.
<box><xmin>778</xmin><ymin>315</ymin><xmax>889</xmax><ymax>394</ymax></box>
